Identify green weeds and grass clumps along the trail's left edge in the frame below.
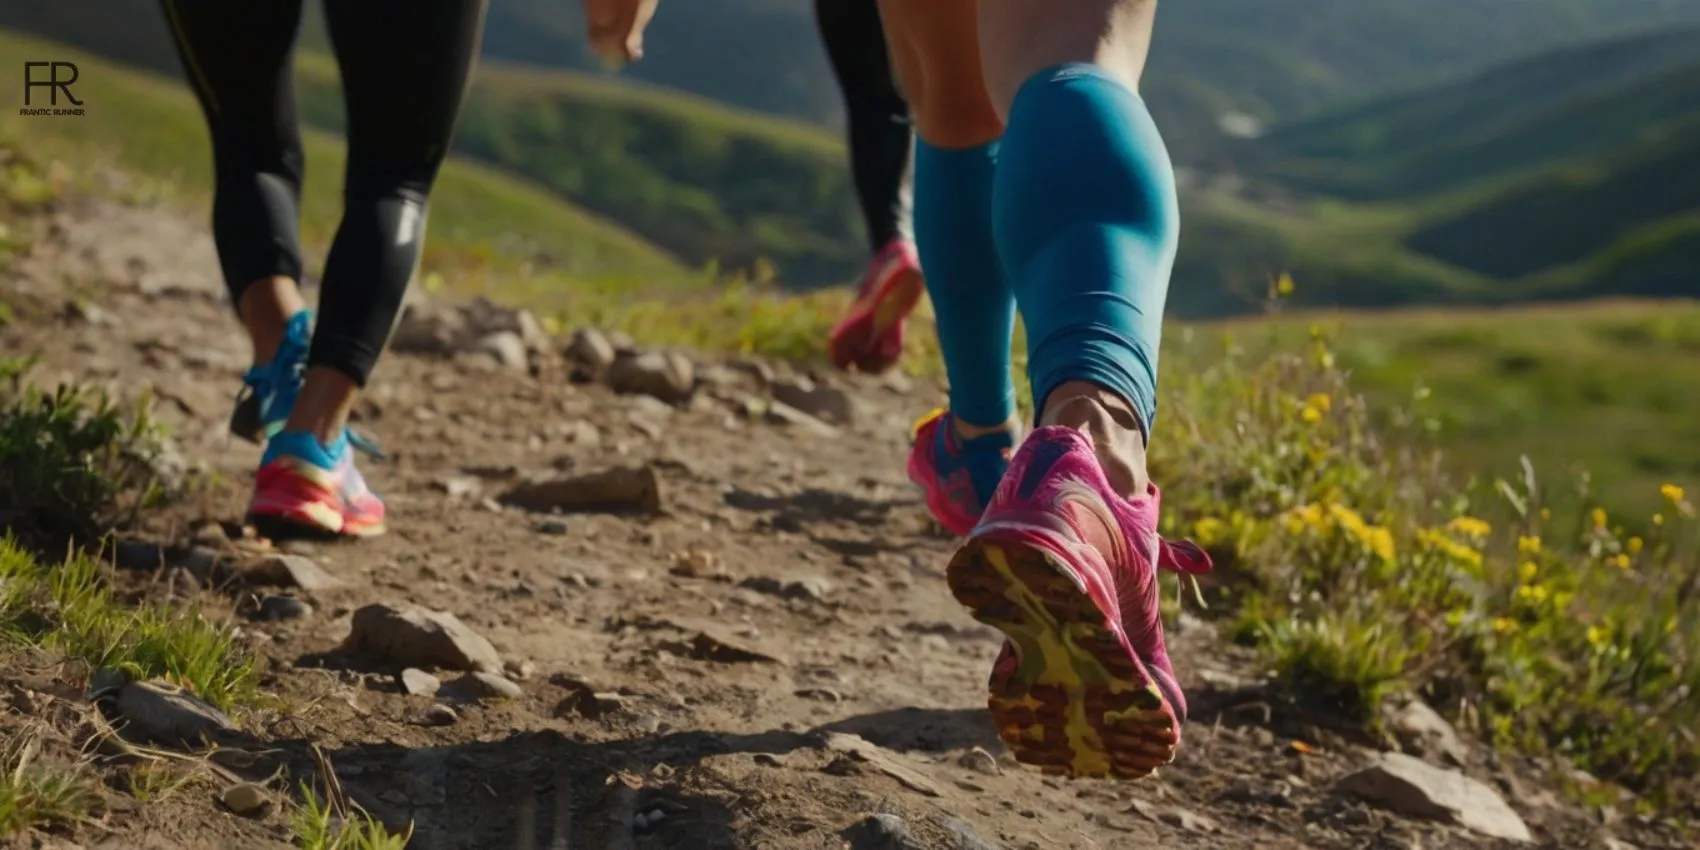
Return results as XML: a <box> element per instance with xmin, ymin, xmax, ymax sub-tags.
<box><xmin>0</xmin><ymin>360</ymin><xmax>406</xmax><ymax>850</ymax></box>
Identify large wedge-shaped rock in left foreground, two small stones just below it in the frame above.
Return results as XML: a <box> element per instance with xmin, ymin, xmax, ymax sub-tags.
<box><xmin>342</xmin><ymin>604</ymin><xmax>502</xmax><ymax>673</ymax></box>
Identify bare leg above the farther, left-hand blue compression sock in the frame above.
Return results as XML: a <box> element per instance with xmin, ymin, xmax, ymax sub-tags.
<box><xmin>879</xmin><ymin>0</ymin><xmax>999</xmax><ymax>148</ymax></box>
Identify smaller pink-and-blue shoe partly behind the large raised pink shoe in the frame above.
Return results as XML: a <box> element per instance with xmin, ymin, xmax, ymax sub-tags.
<box><xmin>910</xmin><ymin>408</ymin><xmax>1015</xmax><ymax>536</ymax></box>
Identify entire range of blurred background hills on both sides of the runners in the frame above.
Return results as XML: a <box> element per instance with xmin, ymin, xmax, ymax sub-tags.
<box><xmin>0</xmin><ymin>0</ymin><xmax>1700</xmax><ymax>309</ymax></box>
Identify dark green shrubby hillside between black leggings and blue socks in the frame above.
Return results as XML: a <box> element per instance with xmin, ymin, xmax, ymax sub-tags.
<box><xmin>287</xmin><ymin>53</ymin><xmax>865</xmax><ymax>287</ymax></box>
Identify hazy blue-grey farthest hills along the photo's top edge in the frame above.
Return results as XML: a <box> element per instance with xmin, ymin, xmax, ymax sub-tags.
<box><xmin>13</xmin><ymin>0</ymin><xmax>1700</xmax><ymax>163</ymax></box>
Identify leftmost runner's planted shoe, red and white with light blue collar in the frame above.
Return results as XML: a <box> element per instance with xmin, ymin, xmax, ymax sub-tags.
<box><xmin>248</xmin><ymin>432</ymin><xmax>384</xmax><ymax>537</ymax></box>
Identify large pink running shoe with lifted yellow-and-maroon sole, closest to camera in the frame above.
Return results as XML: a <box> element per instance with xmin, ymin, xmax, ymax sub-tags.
<box><xmin>947</xmin><ymin>427</ymin><xmax>1210</xmax><ymax>779</ymax></box>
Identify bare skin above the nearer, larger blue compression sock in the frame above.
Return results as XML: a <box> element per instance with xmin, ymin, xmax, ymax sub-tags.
<box><xmin>979</xmin><ymin>0</ymin><xmax>1158</xmax><ymax>117</ymax></box>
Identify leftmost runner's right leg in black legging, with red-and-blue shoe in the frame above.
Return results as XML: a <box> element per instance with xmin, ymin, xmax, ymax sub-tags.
<box><xmin>250</xmin><ymin>0</ymin><xmax>486</xmax><ymax>534</ymax></box>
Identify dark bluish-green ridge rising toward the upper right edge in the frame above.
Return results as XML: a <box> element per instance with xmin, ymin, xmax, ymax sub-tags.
<box><xmin>1236</xmin><ymin>27</ymin><xmax>1700</xmax><ymax>201</ymax></box>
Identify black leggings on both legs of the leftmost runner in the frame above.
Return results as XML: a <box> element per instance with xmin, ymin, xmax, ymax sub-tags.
<box><xmin>162</xmin><ymin>0</ymin><xmax>489</xmax><ymax>386</ymax></box>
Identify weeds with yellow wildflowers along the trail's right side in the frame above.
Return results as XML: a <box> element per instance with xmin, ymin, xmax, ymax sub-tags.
<box><xmin>1154</xmin><ymin>324</ymin><xmax>1700</xmax><ymax>808</ymax></box>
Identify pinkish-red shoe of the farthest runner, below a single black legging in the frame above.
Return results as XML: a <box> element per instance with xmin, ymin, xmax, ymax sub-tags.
<box><xmin>826</xmin><ymin>238</ymin><xmax>927</xmax><ymax>374</ymax></box>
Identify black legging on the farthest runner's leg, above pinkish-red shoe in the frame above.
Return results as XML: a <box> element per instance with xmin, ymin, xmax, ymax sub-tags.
<box><xmin>814</xmin><ymin>0</ymin><xmax>913</xmax><ymax>252</ymax></box>
